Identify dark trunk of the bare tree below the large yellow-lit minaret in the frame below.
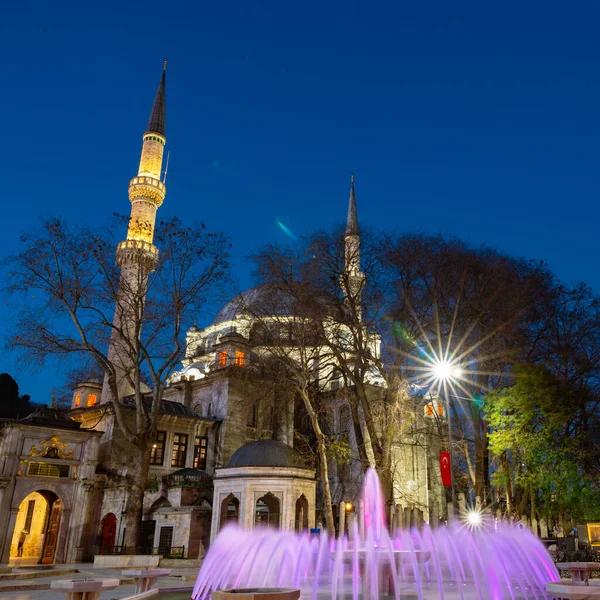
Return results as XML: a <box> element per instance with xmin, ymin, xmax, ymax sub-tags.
<box><xmin>125</xmin><ymin>435</ymin><xmax>151</xmax><ymax>552</ymax></box>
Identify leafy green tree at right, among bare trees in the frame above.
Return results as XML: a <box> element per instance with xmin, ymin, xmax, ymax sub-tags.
<box><xmin>486</xmin><ymin>365</ymin><xmax>600</xmax><ymax>518</ymax></box>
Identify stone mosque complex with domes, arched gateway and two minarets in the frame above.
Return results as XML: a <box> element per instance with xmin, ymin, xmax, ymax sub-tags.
<box><xmin>0</xmin><ymin>64</ymin><xmax>445</xmax><ymax>565</ymax></box>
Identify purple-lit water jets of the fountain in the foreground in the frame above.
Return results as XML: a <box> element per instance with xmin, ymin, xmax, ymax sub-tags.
<box><xmin>192</xmin><ymin>470</ymin><xmax>559</xmax><ymax>600</ymax></box>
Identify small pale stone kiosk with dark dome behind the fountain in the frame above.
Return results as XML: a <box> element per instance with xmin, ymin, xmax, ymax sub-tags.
<box><xmin>211</xmin><ymin>440</ymin><xmax>316</xmax><ymax>541</ymax></box>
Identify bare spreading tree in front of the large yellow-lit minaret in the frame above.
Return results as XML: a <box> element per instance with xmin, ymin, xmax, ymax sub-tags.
<box><xmin>5</xmin><ymin>218</ymin><xmax>229</xmax><ymax>546</ymax></box>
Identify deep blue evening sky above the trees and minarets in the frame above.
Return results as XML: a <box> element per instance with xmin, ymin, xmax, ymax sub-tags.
<box><xmin>0</xmin><ymin>0</ymin><xmax>600</xmax><ymax>402</ymax></box>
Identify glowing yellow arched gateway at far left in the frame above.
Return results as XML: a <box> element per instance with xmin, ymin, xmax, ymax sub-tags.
<box><xmin>10</xmin><ymin>490</ymin><xmax>63</xmax><ymax>564</ymax></box>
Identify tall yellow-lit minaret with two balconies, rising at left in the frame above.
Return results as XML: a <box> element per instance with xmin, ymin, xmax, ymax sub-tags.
<box><xmin>102</xmin><ymin>60</ymin><xmax>167</xmax><ymax>402</ymax></box>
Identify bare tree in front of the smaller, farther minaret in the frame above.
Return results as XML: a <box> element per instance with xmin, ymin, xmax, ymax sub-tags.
<box><xmin>253</xmin><ymin>233</ymin><xmax>408</xmax><ymax>506</ymax></box>
